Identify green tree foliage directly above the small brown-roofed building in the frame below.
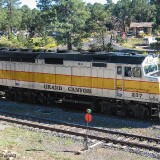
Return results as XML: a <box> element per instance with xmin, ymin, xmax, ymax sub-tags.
<box><xmin>112</xmin><ymin>0</ymin><xmax>157</xmax><ymax>31</ymax></box>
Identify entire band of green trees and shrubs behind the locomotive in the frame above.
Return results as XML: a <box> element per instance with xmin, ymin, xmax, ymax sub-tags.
<box><xmin>0</xmin><ymin>0</ymin><xmax>160</xmax><ymax>49</ymax></box>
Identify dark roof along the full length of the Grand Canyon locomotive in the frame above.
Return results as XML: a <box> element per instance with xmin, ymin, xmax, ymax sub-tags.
<box><xmin>0</xmin><ymin>51</ymin><xmax>146</xmax><ymax>64</ymax></box>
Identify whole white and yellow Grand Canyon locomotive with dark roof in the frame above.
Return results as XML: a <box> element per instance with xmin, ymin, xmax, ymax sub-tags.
<box><xmin>0</xmin><ymin>51</ymin><xmax>160</xmax><ymax>117</ymax></box>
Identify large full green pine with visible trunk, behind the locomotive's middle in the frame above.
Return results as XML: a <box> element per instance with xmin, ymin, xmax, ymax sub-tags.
<box><xmin>52</xmin><ymin>0</ymin><xmax>88</xmax><ymax>50</ymax></box>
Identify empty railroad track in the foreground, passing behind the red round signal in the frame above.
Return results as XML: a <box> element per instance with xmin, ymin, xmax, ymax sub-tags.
<box><xmin>0</xmin><ymin>112</ymin><xmax>160</xmax><ymax>153</ymax></box>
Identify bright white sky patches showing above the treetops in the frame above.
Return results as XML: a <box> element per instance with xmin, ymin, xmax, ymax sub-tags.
<box><xmin>21</xmin><ymin>0</ymin><xmax>118</xmax><ymax>9</ymax></box>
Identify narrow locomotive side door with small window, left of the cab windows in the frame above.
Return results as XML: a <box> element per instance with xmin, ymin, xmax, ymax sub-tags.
<box><xmin>115</xmin><ymin>66</ymin><xmax>124</xmax><ymax>98</ymax></box>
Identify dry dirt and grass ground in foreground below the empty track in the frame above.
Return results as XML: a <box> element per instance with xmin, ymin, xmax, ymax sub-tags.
<box><xmin>0</xmin><ymin>123</ymin><xmax>155</xmax><ymax>160</ymax></box>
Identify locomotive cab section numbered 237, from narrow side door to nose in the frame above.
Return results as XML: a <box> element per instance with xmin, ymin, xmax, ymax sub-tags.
<box><xmin>112</xmin><ymin>55</ymin><xmax>160</xmax><ymax>117</ymax></box>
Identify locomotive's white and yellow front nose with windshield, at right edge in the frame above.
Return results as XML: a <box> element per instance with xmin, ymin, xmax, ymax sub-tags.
<box><xmin>142</xmin><ymin>55</ymin><xmax>160</xmax><ymax>117</ymax></box>
